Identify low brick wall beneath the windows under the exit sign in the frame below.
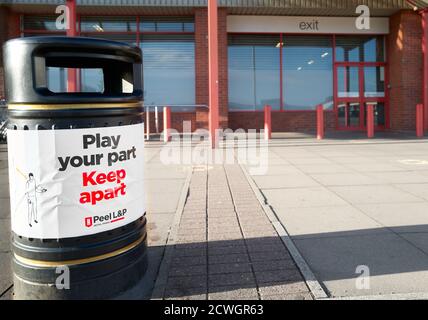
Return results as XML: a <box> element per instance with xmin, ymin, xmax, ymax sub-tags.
<box><xmin>229</xmin><ymin>111</ymin><xmax>335</xmax><ymax>132</ymax></box>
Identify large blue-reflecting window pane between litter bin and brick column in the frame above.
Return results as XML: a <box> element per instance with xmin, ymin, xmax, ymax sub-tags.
<box><xmin>140</xmin><ymin>35</ymin><xmax>195</xmax><ymax>106</ymax></box>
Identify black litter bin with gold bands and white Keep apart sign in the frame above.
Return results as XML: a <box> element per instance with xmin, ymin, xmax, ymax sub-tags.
<box><xmin>3</xmin><ymin>37</ymin><xmax>147</xmax><ymax>299</ymax></box>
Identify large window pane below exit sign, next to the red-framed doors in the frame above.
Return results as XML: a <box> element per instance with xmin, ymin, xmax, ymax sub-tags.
<box><xmin>282</xmin><ymin>36</ymin><xmax>333</xmax><ymax>110</ymax></box>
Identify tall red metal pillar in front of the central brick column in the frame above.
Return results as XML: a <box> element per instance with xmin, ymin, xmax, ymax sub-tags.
<box><xmin>208</xmin><ymin>0</ymin><xmax>219</xmax><ymax>148</ymax></box>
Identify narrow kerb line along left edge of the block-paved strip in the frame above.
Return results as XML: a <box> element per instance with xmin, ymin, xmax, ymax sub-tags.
<box><xmin>151</xmin><ymin>168</ymin><xmax>193</xmax><ymax>300</ymax></box>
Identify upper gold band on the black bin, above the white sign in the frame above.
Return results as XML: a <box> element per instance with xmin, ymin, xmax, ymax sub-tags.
<box><xmin>8</xmin><ymin>102</ymin><xmax>143</xmax><ymax>111</ymax></box>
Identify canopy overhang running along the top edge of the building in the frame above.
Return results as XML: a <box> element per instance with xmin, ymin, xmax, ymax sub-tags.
<box><xmin>0</xmin><ymin>0</ymin><xmax>428</xmax><ymax>17</ymax></box>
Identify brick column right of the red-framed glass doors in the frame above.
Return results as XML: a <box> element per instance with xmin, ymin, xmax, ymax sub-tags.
<box><xmin>387</xmin><ymin>11</ymin><xmax>423</xmax><ymax>131</ymax></box>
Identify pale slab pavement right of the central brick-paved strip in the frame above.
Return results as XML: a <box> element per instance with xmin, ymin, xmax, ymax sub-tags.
<box><xmin>244</xmin><ymin>135</ymin><xmax>428</xmax><ymax>297</ymax></box>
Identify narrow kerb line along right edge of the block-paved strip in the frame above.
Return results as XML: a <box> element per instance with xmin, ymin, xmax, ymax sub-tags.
<box><xmin>240</xmin><ymin>165</ymin><xmax>329</xmax><ymax>299</ymax></box>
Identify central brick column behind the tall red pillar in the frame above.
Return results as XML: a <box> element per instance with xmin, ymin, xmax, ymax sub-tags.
<box><xmin>195</xmin><ymin>8</ymin><xmax>228</xmax><ymax>128</ymax></box>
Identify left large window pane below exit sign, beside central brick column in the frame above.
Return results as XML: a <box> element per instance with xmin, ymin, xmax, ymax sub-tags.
<box><xmin>228</xmin><ymin>36</ymin><xmax>280</xmax><ymax>110</ymax></box>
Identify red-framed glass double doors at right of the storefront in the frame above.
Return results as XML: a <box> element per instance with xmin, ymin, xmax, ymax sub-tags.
<box><xmin>335</xmin><ymin>63</ymin><xmax>387</xmax><ymax>130</ymax></box>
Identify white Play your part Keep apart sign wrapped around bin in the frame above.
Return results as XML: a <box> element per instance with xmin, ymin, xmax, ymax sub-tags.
<box><xmin>7</xmin><ymin>124</ymin><xmax>145</xmax><ymax>239</ymax></box>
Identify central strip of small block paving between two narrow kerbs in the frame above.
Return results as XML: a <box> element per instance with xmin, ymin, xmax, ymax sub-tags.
<box><xmin>152</xmin><ymin>165</ymin><xmax>312</xmax><ymax>300</ymax></box>
